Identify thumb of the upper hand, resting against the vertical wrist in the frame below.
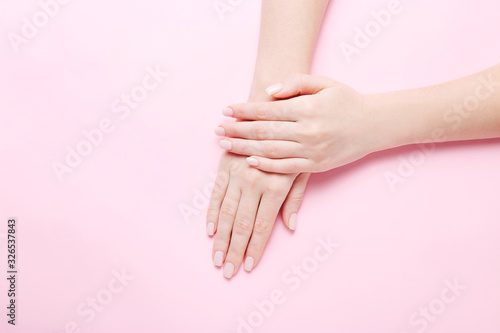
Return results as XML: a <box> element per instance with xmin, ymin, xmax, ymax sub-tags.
<box><xmin>266</xmin><ymin>74</ymin><xmax>336</xmax><ymax>98</ymax></box>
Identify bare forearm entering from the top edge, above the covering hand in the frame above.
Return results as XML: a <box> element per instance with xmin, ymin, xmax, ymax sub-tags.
<box><xmin>250</xmin><ymin>0</ymin><xmax>329</xmax><ymax>100</ymax></box>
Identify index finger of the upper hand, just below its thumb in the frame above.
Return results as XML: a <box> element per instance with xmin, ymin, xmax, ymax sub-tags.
<box><xmin>222</xmin><ymin>100</ymin><xmax>298</xmax><ymax>121</ymax></box>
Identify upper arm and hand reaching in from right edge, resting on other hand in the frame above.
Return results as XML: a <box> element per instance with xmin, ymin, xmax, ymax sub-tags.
<box><xmin>219</xmin><ymin>64</ymin><xmax>500</xmax><ymax>174</ymax></box>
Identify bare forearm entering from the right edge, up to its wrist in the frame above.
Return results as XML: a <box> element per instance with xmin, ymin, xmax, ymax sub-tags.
<box><xmin>367</xmin><ymin>64</ymin><xmax>500</xmax><ymax>149</ymax></box>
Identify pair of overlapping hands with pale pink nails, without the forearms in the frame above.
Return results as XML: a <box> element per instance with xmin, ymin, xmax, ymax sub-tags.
<box><xmin>207</xmin><ymin>75</ymin><xmax>384</xmax><ymax>278</ymax></box>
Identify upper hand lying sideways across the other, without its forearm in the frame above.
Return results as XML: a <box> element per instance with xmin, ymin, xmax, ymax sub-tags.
<box><xmin>215</xmin><ymin>75</ymin><xmax>396</xmax><ymax>174</ymax></box>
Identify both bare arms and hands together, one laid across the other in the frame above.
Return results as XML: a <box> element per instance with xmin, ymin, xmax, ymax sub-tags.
<box><xmin>207</xmin><ymin>0</ymin><xmax>500</xmax><ymax>278</ymax></box>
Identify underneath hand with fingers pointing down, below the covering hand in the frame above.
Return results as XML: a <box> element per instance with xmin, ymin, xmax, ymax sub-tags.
<box><xmin>207</xmin><ymin>153</ymin><xmax>309</xmax><ymax>278</ymax></box>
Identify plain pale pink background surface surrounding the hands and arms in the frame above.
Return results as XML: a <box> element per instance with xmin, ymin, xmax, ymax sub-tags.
<box><xmin>0</xmin><ymin>0</ymin><xmax>500</xmax><ymax>333</ymax></box>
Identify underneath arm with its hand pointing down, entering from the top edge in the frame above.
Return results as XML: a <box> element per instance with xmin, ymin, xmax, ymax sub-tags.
<box><xmin>207</xmin><ymin>0</ymin><xmax>328</xmax><ymax>278</ymax></box>
